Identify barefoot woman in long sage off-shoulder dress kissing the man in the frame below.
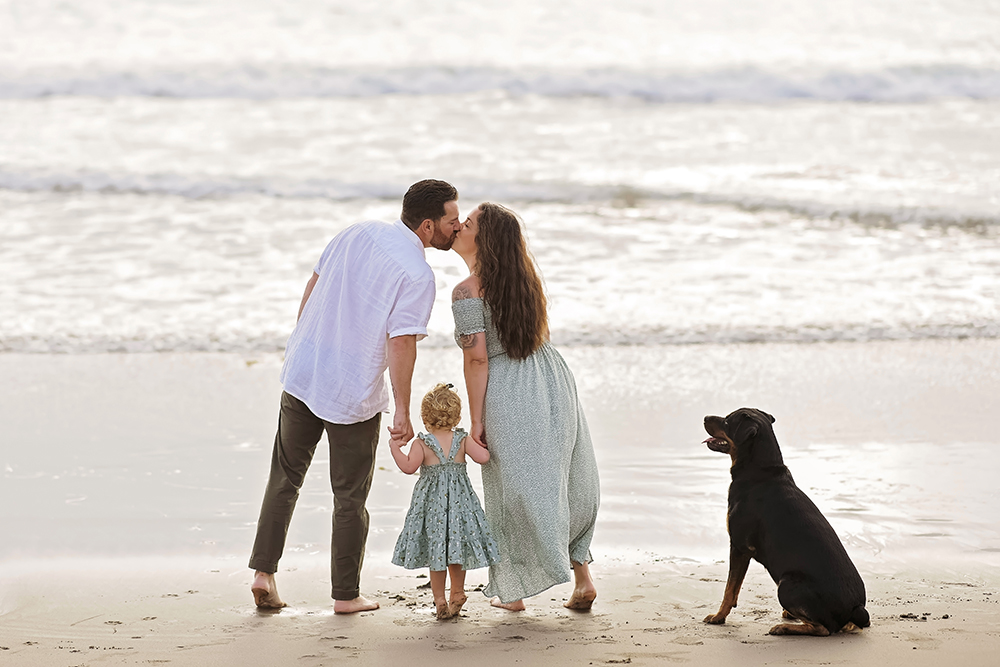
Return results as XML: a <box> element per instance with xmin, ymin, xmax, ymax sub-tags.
<box><xmin>452</xmin><ymin>203</ymin><xmax>600</xmax><ymax>611</ymax></box>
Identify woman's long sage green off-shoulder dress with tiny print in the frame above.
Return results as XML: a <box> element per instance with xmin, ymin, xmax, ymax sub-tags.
<box><xmin>452</xmin><ymin>298</ymin><xmax>600</xmax><ymax>602</ymax></box>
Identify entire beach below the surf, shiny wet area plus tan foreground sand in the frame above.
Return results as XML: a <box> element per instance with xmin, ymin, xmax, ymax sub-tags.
<box><xmin>0</xmin><ymin>340</ymin><xmax>1000</xmax><ymax>666</ymax></box>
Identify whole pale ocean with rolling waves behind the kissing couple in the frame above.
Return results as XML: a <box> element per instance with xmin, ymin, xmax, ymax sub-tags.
<box><xmin>0</xmin><ymin>0</ymin><xmax>1000</xmax><ymax>353</ymax></box>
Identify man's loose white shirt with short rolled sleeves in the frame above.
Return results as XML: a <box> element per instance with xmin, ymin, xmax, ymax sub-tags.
<box><xmin>281</xmin><ymin>220</ymin><xmax>435</xmax><ymax>424</ymax></box>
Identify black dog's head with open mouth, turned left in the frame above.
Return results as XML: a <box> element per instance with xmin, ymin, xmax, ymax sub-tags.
<box><xmin>705</xmin><ymin>408</ymin><xmax>784</xmax><ymax>468</ymax></box>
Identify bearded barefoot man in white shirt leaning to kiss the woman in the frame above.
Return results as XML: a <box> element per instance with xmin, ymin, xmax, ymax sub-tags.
<box><xmin>250</xmin><ymin>180</ymin><xmax>461</xmax><ymax>614</ymax></box>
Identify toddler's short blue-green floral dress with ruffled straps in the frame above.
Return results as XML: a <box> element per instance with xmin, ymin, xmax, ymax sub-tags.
<box><xmin>392</xmin><ymin>429</ymin><xmax>500</xmax><ymax>571</ymax></box>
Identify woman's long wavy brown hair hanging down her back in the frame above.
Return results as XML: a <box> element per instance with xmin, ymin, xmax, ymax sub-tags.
<box><xmin>475</xmin><ymin>202</ymin><xmax>549</xmax><ymax>359</ymax></box>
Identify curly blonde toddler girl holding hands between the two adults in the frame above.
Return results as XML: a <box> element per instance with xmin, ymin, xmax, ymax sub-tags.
<box><xmin>389</xmin><ymin>384</ymin><xmax>500</xmax><ymax>619</ymax></box>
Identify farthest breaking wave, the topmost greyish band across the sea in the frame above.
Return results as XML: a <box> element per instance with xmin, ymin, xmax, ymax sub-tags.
<box><xmin>0</xmin><ymin>65</ymin><xmax>1000</xmax><ymax>103</ymax></box>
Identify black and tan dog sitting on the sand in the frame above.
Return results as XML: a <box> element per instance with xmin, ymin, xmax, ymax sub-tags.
<box><xmin>705</xmin><ymin>408</ymin><xmax>869</xmax><ymax>636</ymax></box>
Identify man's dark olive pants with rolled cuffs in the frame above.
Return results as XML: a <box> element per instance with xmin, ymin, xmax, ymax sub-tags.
<box><xmin>250</xmin><ymin>392</ymin><xmax>382</xmax><ymax>600</ymax></box>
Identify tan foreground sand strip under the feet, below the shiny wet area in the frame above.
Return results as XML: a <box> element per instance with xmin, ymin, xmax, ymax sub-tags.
<box><xmin>0</xmin><ymin>559</ymin><xmax>1000</xmax><ymax>666</ymax></box>
